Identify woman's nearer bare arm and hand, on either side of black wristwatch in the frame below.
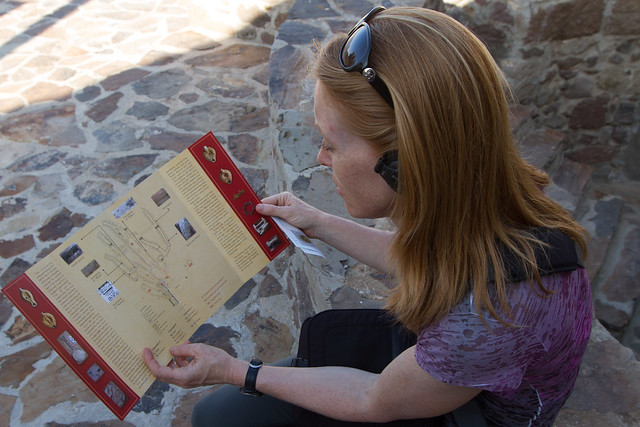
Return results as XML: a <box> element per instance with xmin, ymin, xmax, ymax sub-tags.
<box><xmin>145</xmin><ymin>344</ymin><xmax>480</xmax><ymax>422</ymax></box>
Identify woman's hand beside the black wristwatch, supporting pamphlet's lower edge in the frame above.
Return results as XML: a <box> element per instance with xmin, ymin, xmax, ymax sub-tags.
<box><xmin>143</xmin><ymin>344</ymin><xmax>239</xmax><ymax>388</ymax></box>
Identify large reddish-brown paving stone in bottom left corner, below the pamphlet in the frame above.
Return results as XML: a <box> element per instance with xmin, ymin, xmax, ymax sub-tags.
<box><xmin>20</xmin><ymin>357</ymin><xmax>98</xmax><ymax>423</ymax></box>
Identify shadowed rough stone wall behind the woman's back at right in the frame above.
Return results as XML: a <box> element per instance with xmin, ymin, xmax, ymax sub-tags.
<box><xmin>440</xmin><ymin>0</ymin><xmax>640</xmax><ymax>355</ymax></box>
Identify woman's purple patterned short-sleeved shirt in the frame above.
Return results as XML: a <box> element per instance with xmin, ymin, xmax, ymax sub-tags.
<box><xmin>415</xmin><ymin>268</ymin><xmax>592</xmax><ymax>426</ymax></box>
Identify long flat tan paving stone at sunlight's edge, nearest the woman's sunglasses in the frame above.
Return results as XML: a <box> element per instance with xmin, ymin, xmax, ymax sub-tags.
<box><xmin>186</xmin><ymin>44</ymin><xmax>271</xmax><ymax>68</ymax></box>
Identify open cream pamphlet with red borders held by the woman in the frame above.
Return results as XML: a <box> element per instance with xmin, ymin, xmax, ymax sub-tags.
<box><xmin>2</xmin><ymin>133</ymin><xmax>308</xmax><ymax>420</ymax></box>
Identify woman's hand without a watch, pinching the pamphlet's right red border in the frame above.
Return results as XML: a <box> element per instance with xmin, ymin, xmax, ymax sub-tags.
<box><xmin>256</xmin><ymin>191</ymin><xmax>328</xmax><ymax>239</ymax></box>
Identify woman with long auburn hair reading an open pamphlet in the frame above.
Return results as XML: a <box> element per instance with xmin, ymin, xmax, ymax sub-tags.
<box><xmin>145</xmin><ymin>7</ymin><xmax>591</xmax><ymax>425</ymax></box>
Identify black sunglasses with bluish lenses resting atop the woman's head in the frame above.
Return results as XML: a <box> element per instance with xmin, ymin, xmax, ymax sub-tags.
<box><xmin>339</xmin><ymin>6</ymin><xmax>393</xmax><ymax>108</ymax></box>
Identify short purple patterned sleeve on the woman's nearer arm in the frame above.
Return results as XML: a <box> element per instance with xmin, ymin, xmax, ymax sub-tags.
<box><xmin>415</xmin><ymin>312</ymin><xmax>544</xmax><ymax>392</ymax></box>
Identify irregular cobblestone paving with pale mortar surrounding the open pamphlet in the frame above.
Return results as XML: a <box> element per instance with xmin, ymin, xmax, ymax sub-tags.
<box><xmin>0</xmin><ymin>0</ymin><xmax>640</xmax><ymax>426</ymax></box>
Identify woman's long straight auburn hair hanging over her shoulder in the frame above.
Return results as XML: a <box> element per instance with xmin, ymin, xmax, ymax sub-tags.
<box><xmin>314</xmin><ymin>8</ymin><xmax>586</xmax><ymax>331</ymax></box>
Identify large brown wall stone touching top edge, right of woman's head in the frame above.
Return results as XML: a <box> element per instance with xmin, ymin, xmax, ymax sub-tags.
<box><xmin>526</xmin><ymin>0</ymin><xmax>604</xmax><ymax>42</ymax></box>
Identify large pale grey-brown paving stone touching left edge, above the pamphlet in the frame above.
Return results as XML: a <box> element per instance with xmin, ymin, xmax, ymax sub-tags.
<box><xmin>0</xmin><ymin>104</ymin><xmax>86</xmax><ymax>147</ymax></box>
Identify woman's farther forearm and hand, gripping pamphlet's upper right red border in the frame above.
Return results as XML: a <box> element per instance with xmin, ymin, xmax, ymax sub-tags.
<box><xmin>256</xmin><ymin>192</ymin><xmax>394</xmax><ymax>273</ymax></box>
